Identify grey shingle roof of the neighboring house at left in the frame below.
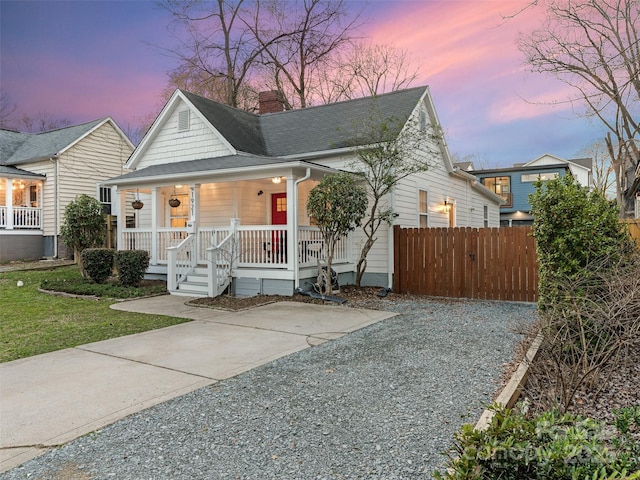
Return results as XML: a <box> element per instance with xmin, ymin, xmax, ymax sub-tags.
<box><xmin>0</xmin><ymin>119</ymin><xmax>104</xmax><ymax>165</ymax></box>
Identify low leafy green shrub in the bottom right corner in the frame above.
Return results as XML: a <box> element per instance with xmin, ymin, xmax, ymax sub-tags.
<box><xmin>434</xmin><ymin>405</ymin><xmax>640</xmax><ymax>480</ymax></box>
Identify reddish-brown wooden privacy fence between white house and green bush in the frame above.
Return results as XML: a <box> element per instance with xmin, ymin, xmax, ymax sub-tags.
<box><xmin>394</xmin><ymin>226</ymin><xmax>538</xmax><ymax>302</ymax></box>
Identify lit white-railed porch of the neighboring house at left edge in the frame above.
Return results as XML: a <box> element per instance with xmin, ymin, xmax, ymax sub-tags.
<box><xmin>0</xmin><ymin>177</ymin><xmax>44</xmax><ymax>262</ymax></box>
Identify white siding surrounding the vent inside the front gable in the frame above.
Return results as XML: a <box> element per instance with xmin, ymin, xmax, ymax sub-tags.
<box><xmin>136</xmin><ymin>101</ymin><xmax>232</xmax><ymax>170</ymax></box>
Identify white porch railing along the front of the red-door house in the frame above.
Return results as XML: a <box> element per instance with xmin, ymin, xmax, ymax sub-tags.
<box><xmin>122</xmin><ymin>225</ymin><xmax>351</xmax><ymax>269</ymax></box>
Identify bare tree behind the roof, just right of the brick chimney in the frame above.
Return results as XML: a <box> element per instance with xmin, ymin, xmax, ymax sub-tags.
<box><xmin>247</xmin><ymin>0</ymin><xmax>359</xmax><ymax>109</ymax></box>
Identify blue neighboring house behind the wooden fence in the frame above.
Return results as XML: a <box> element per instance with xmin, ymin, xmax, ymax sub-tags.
<box><xmin>456</xmin><ymin>154</ymin><xmax>593</xmax><ymax>227</ymax></box>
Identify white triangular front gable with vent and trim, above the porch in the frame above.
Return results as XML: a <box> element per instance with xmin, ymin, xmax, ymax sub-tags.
<box><xmin>127</xmin><ymin>90</ymin><xmax>237</xmax><ymax>169</ymax></box>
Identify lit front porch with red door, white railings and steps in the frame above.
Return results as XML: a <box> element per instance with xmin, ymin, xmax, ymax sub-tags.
<box><xmin>118</xmin><ymin>177</ymin><xmax>354</xmax><ymax>297</ymax></box>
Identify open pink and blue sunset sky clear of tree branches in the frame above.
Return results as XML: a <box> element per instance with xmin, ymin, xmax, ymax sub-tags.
<box><xmin>0</xmin><ymin>0</ymin><xmax>603</xmax><ymax>168</ymax></box>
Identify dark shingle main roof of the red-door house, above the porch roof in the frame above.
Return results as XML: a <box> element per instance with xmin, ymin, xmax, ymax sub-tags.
<box><xmin>182</xmin><ymin>87</ymin><xmax>426</xmax><ymax>156</ymax></box>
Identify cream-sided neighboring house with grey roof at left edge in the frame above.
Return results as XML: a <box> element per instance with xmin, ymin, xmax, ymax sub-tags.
<box><xmin>0</xmin><ymin>118</ymin><xmax>134</xmax><ymax>262</ymax></box>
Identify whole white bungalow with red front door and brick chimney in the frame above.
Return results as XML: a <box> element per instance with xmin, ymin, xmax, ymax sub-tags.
<box><xmin>106</xmin><ymin>87</ymin><xmax>502</xmax><ymax>296</ymax></box>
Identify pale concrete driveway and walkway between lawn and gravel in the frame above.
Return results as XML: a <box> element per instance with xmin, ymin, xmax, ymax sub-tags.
<box><xmin>0</xmin><ymin>295</ymin><xmax>395</xmax><ymax>473</ymax></box>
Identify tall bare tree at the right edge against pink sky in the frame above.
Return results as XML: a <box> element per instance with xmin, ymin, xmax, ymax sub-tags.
<box><xmin>519</xmin><ymin>0</ymin><xmax>640</xmax><ymax>208</ymax></box>
